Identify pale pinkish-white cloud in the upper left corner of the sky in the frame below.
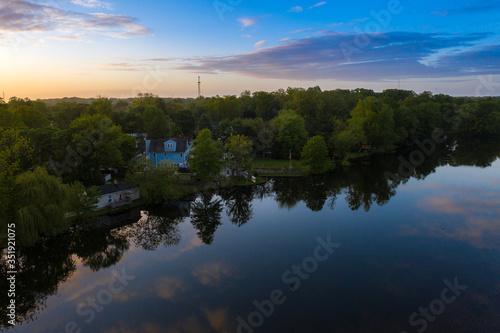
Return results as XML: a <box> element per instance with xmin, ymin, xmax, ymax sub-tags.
<box><xmin>0</xmin><ymin>0</ymin><xmax>151</xmax><ymax>38</ymax></box>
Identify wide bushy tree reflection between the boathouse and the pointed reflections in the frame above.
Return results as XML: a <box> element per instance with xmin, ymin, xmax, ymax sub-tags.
<box><xmin>120</xmin><ymin>211</ymin><xmax>184</xmax><ymax>251</ymax></box>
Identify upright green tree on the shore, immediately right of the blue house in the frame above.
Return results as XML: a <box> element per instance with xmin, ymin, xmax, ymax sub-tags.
<box><xmin>189</xmin><ymin>129</ymin><xmax>222</xmax><ymax>179</ymax></box>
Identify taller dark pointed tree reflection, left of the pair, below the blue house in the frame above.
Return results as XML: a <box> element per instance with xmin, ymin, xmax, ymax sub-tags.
<box><xmin>191</xmin><ymin>193</ymin><xmax>222</xmax><ymax>244</ymax></box>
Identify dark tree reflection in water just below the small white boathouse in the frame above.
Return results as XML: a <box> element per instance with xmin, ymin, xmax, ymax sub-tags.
<box><xmin>73</xmin><ymin>231</ymin><xmax>129</xmax><ymax>272</ymax></box>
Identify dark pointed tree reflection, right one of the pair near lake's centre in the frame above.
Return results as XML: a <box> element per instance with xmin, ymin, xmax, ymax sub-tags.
<box><xmin>221</xmin><ymin>187</ymin><xmax>253</xmax><ymax>227</ymax></box>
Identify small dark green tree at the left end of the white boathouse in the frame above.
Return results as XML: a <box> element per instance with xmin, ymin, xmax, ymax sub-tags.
<box><xmin>67</xmin><ymin>182</ymin><xmax>101</xmax><ymax>215</ymax></box>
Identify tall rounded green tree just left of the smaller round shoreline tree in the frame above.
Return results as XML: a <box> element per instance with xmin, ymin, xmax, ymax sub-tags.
<box><xmin>274</xmin><ymin>110</ymin><xmax>307</xmax><ymax>158</ymax></box>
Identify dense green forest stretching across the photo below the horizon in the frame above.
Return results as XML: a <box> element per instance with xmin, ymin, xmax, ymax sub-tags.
<box><xmin>0</xmin><ymin>87</ymin><xmax>500</xmax><ymax>244</ymax></box>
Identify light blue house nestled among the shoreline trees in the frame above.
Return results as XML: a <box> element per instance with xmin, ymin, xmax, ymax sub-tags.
<box><xmin>146</xmin><ymin>138</ymin><xmax>193</xmax><ymax>168</ymax></box>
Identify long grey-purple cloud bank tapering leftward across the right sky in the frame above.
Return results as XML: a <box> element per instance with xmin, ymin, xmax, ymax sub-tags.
<box><xmin>177</xmin><ymin>31</ymin><xmax>500</xmax><ymax>81</ymax></box>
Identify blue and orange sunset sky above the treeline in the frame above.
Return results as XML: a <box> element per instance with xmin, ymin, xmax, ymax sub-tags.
<box><xmin>0</xmin><ymin>0</ymin><xmax>500</xmax><ymax>99</ymax></box>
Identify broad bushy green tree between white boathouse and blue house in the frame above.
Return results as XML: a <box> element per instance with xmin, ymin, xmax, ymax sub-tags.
<box><xmin>127</xmin><ymin>158</ymin><xmax>180</xmax><ymax>204</ymax></box>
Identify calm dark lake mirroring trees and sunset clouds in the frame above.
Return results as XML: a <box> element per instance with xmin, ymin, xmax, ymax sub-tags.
<box><xmin>0</xmin><ymin>142</ymin><xmax>500</xmax><ymax>333</ymax></box>
